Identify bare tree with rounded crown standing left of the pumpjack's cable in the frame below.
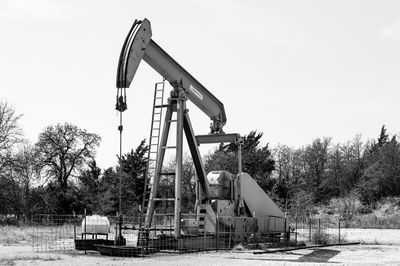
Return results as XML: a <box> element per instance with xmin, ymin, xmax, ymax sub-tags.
<box><xmin>35</xmin><ymin>123</ymin><xmax>101</xmax><ymax>189</ymax></box>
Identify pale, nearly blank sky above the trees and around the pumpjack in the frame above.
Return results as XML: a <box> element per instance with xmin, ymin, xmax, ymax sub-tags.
<box><xmin>0</xmin><ymin>0</ymin><xmax>400</xmax><ymax>168</ymax></box>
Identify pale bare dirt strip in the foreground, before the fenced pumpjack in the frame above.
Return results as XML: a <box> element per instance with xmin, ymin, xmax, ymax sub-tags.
<box><xmin>0</xmin><ymin>244</ymin><xmax>400</xmax><ymax>266</ymax></box>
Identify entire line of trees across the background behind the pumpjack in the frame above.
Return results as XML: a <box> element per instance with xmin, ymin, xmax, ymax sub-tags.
<box><xmin>0</xmin><ymin>102</ymin><xmax>400</xmax><ymax>219</ymax></box>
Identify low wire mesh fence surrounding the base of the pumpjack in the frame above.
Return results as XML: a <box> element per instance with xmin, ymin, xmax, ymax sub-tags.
<box><xmin>32</xmin><ymin>214</ymin><xmax>356</xmax><ymax>256</ymax></box>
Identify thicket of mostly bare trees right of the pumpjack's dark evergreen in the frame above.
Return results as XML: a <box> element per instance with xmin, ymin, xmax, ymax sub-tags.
<box><xmin>274</xmin><ymin>126</ymin><xmax>400</xmax><ymax>213</ymax></box>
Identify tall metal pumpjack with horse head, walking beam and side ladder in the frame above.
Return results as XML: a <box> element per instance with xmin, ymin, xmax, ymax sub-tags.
<box><xmin>107</xmin><ymin>19</ymin><xmax>288</xmax><ymax>254</ymax></box>
